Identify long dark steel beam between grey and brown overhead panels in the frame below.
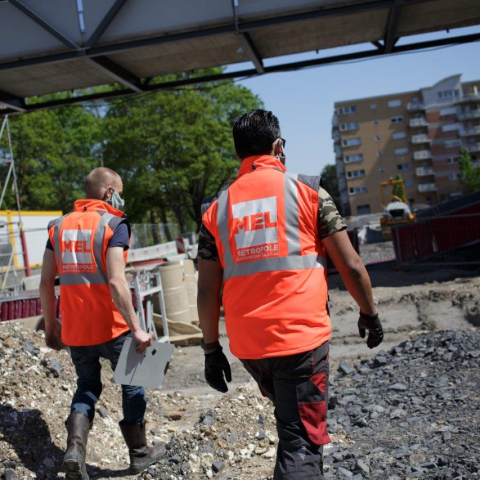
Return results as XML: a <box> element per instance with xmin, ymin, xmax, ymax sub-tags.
<box><xmin>0</xmin><ymin>0</ymin><xmax>434</xmax><ymax>71</ymax></box>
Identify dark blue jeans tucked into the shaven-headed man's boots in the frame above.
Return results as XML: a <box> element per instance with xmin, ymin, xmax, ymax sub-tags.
<box><xmin>70</xmin><ymin>332</ymin><xmax>147</xmax><ymax>424</ymax></box>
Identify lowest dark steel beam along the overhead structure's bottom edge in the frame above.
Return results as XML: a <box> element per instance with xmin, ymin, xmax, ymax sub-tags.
<box><xmin>0</xmin><ymin>33</ymin><xmax>480</xmax><ymax>117</ymax></box>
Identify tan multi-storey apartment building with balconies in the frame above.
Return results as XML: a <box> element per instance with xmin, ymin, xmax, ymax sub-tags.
<box><xmin>332</xmin><ymin>75</ymin><xmax>480</xmax><ymax>215</ymax></box>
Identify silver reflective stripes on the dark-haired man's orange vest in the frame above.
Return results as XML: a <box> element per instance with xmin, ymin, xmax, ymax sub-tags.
<box><xmin>217</xmin><ymin>173</ymin><xmax>326</xmax><ymax>281</ymax></box>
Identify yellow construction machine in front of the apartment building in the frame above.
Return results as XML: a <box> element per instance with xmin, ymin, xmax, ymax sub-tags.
<box><xmin>380</xmin><ymin>178</ymin><xmax>415</xmax><ymax>241</ymax></box>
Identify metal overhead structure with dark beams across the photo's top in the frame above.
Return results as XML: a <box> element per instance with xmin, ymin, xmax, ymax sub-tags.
<box><xmin>0</xmin><ymin>0</ymin><xmax>480</xmax><ymax>115</ymax></box>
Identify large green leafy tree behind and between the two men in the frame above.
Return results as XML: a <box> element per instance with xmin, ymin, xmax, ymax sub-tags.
<box><xmin>103</xmin><ymin>69</ymin><xmax>262</xmax><ymax>231</ymax></box>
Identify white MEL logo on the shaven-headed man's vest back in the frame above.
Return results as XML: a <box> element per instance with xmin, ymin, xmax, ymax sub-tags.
<box><xmin>62</xmin><ymin>230</ymin><xmax>95</xmax><ymax>273</ymax></box>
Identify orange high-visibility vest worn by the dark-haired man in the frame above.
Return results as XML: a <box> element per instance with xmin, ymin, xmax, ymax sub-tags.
<box><xmin>202</xmin><ymin>155</ymin><xmax>331</xmax><ymax>359</ymax></box>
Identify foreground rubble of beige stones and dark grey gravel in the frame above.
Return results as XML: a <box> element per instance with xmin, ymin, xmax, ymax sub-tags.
<box><xmin>0</xmin><ymin>318</ymin><xmax>480</xmax><ymax>480</ymax></box>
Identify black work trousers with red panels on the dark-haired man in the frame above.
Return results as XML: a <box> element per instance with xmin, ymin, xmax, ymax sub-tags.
<box><xmin>242</xmin><ymin>342</ymin><xmax>330</xmax><ymax>480</ymax></box>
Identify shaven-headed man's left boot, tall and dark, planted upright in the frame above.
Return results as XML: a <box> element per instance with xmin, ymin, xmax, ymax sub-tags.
<box><xmin>63</xmin><ymin>413</ymin><xmax>90</xmax><ymax>480</ymax></box>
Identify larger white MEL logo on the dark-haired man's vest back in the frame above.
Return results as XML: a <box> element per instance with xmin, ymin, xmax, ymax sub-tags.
<box><xmin>232</xmin><ymin>197</ymin><xmax>280</xmax><ymax>263</ymax></box>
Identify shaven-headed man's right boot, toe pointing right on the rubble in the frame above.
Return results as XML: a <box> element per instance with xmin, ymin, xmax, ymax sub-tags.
<box><xmin>120</xmin><ymin>421</ymin><xmax>166</xmax><ymax>473</ymax></box>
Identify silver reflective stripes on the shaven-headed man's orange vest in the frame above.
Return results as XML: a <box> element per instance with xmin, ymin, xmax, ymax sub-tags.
<box><xmin>53</xmin><ymin>212</ymin><xmax>114</xmax><ymax>285</ymax></box>
